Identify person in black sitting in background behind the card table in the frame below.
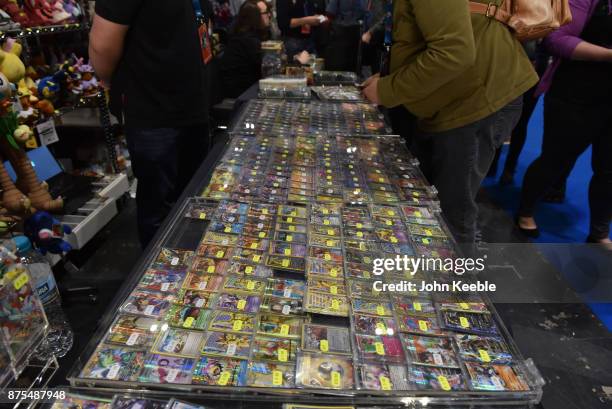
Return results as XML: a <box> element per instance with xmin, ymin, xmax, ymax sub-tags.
<box><xmin>219</xmin><ymin>0</ymin><xmax>271</xmax><ymax>98</ymax></box>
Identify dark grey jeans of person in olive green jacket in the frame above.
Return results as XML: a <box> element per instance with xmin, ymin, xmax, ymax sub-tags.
<box><xmin>413</xmin><ymin>97</ymin><xmax>523</xmax><ymax>251</ymax></box>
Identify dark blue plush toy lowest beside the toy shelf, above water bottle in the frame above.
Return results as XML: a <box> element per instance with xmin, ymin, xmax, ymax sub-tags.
<box><xmin>23</xmin><ymin>211</ymin><xmax>72</xmax><ymax>255</ymax></box>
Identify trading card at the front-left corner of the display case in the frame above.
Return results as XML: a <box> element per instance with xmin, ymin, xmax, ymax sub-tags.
<box><xmin>81</xmin><ymin>346</ymin><xmax>145</xmax><ymax>382</ymax></box>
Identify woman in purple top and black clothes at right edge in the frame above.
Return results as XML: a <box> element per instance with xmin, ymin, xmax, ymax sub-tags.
<box><xmin>517</xmin><ymin>0</ymin><xmax>612</xmax><ymax>245</ymax></box>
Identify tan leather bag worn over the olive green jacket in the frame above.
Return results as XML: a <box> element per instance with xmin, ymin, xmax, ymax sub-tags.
<box><xmin>470</xmin><ymin>0</ymin><xmax>572</xmax><ymax>41</ymax></box>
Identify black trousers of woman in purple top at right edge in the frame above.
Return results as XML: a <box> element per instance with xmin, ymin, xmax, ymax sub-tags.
<box><xmin>519</xmin><ymin>95</ymin><xmax>612</xmax><ymax>240</ymax></box>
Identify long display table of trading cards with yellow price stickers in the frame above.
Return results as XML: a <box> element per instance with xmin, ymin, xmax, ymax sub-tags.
<box><xmin>60</xmin><ymin>89</ymin><xmax>543</xmax><ymax>408</ymax></box>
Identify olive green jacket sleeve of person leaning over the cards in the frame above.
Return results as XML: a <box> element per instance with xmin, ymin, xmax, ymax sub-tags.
<box><xmin>378</xmin><ymin>0</ymin><xmax>476</xmax><ymax>107</ymax></box>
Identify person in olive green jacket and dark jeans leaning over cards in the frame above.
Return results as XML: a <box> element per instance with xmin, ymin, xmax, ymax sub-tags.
<box><xmin>363</xmin><ymin>0</ymin><xmax>538</xmax><ymax>248</ymax></box>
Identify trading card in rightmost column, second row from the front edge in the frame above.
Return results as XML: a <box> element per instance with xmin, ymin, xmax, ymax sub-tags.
<box><xmin>455</xmin><ymin>334</ymin><xmax>512</xmax><ymax>364</ymax></box>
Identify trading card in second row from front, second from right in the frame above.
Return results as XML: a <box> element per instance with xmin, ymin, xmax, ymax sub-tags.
<box><xmin>401</xmin><ymin>334</ymin><xmax>459</xmax><ymax>368</ymax></box>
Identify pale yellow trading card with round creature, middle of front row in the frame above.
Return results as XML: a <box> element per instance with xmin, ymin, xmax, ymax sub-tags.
<box><xmin>296</xmin><ymin>353</ymin><xmax>355</xmax><ymax>390</ymax></box>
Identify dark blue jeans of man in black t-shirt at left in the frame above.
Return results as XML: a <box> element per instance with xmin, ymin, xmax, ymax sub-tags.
<box><xmin>126</xmin><ymin>124</ymin><xmax>208</xmax><ymax>248</ymax></box>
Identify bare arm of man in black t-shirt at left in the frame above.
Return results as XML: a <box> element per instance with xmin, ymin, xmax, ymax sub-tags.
<box><xmin>89</xmin><ymin>15</ymin><xmax>129</xmax><ymax>85</ymax></box>
